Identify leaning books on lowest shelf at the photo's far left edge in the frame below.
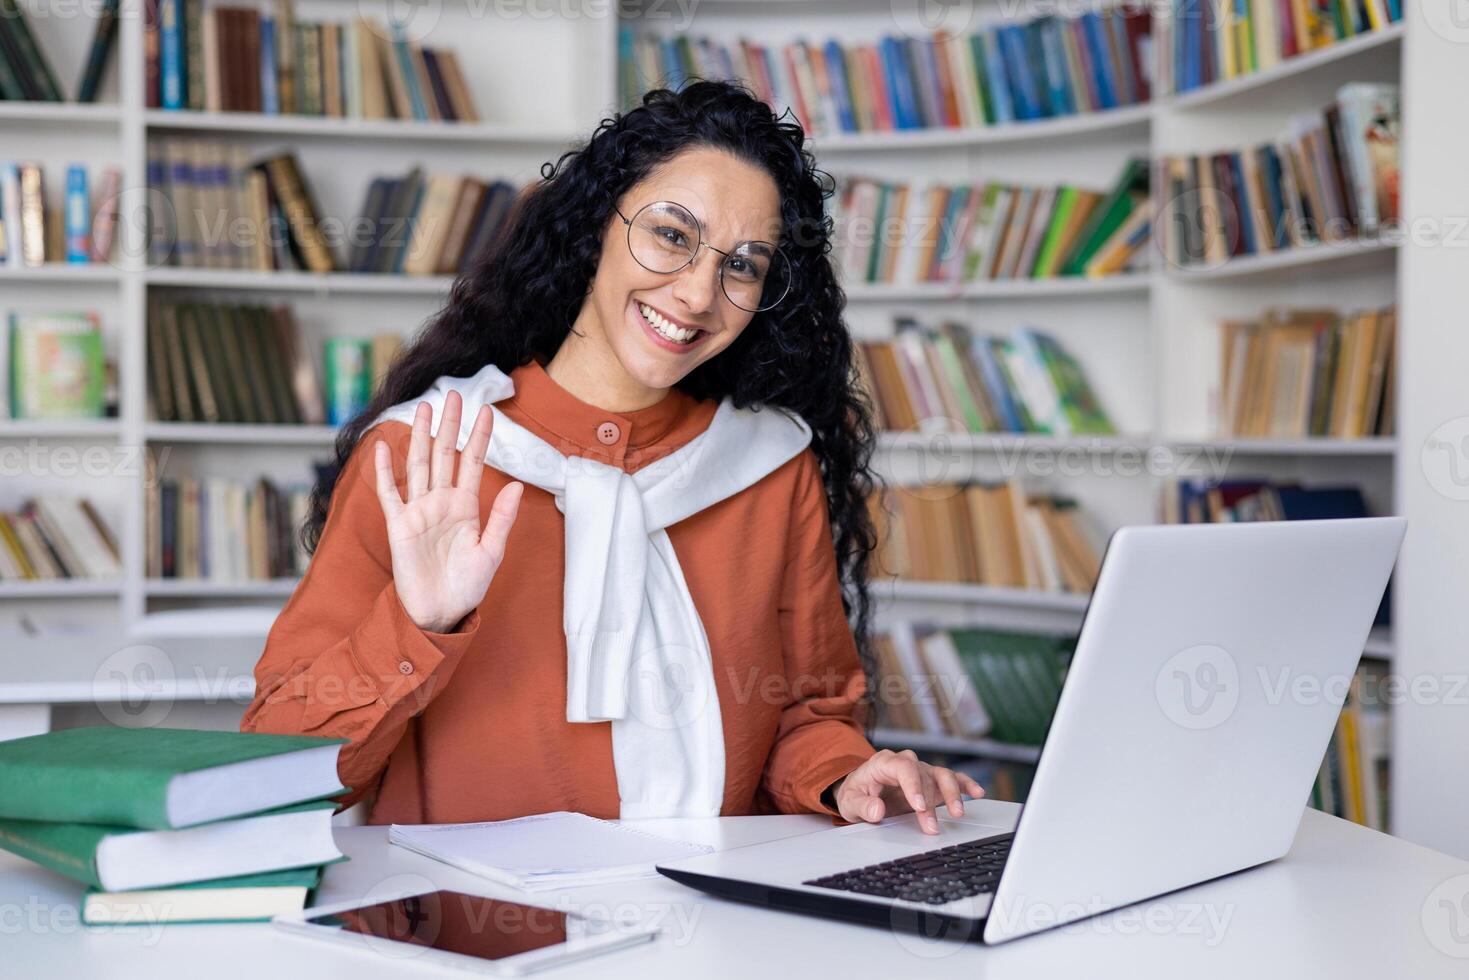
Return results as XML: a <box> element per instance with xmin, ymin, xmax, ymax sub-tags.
<box><xmin>0</xmin><ymin>497</ymin><xmax>122</xmax><ymax>582</ymax></box>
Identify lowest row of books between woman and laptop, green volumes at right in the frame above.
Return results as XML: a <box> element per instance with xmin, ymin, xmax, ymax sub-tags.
<box><xmin>874</xmin><ymin>620</ymin><xmax>1072</xmax><ymax>745</ymax></box>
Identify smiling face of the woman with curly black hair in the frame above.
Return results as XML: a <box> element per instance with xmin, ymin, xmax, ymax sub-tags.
<box><xmin>576</xmin><ymin>147</ymin><xmax>782</xmax><ymax>389</ymax></box>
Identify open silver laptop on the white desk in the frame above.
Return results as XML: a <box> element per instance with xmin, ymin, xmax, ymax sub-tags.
<box><xmin>658</xmin><ymin>517</ymin><xmax>1406</xmax><ymax>943</ymax></box>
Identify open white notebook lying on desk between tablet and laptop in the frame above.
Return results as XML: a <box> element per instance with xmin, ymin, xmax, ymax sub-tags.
<box><xmin>388</xmin><ymin>811</ymin><xmax>714</xmax><ymax>892</ymax></box>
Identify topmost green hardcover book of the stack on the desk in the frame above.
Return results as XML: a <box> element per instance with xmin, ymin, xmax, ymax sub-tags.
<box><xmin>0</xmin><ymin>724</ymin><xmax>345</xmax><ymax>830</ymax></box>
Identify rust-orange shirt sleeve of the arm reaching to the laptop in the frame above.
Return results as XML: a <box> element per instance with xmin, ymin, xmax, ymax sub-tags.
<box><xmin>764</xmin><ymin>448</ymin><xmax>874</xmax><ymax>815</ymax></box>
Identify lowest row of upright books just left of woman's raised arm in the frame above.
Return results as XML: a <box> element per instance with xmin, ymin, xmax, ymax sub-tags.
<box><xmin>144</xmin><ymin>476</ymin><xmax>311</xmax><ymax>582</ymax></box>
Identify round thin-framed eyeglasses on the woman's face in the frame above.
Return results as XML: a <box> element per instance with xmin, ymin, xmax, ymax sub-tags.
<box><xmin>614</xmin><ymin>201</ymin><xmax>790</xmax><ymax>313</ymax></box>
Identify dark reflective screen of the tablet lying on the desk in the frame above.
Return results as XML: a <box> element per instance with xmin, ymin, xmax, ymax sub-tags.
<box><xmin>306</xmin><ymin>890</ymin><xmax>566</xmax><ymax>959</ymax></box>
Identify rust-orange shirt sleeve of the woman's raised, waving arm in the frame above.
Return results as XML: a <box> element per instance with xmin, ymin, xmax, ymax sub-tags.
<box><xmin>239</xmin><ymin>422</ymin><xmax>480</xmax><ymax>807</ymax></box>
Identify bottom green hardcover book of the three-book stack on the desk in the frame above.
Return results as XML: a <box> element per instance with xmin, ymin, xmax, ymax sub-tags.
<box><xmin>82</xmin><ymin>855</ymin><xmax>336</xmax><ymax>926</ymax></box>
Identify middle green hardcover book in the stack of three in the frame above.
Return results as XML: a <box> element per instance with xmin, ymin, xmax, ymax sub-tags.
<box><xmin>0</xmin><ymin>801</ymin><xmax>342</xmax><ymax>892</ymax></box>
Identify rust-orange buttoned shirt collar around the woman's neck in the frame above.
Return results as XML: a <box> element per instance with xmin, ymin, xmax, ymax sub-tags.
<box><xmin>498</xmin><ymin>359</ymin><xmax>718</xmax><ymax>472</ymax></box>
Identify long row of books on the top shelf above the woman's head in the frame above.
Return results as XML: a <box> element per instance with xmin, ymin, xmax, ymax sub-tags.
<box><xmin>618</xmin><ymin>3</ymin><xmax>1152</xmax><ymax>137</ymax></box>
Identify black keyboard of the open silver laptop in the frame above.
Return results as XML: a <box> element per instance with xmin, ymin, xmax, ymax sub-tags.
<box><xmin>802</xmin><ymin>833</ymin><xmax>1015</xmax><ymax>905</ymax></box>
